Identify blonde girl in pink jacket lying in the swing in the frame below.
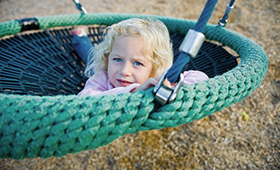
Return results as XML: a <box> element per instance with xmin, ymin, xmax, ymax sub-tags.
<box><xmin>72</xmin><ymin>19</ymin><xmax>208</xmax><ymax>96</ymax></box>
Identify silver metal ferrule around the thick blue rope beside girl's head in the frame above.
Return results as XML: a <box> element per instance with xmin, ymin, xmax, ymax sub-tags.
<box><xmin>179</xmin><ymin>29</ymin><xmax>205</xmax><ymax>58</ymax></box>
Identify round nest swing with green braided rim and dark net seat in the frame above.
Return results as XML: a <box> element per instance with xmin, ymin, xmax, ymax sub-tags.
<box><xmin>0</xmin><ymin>0</ymin><xmax>268</xmax><ymax>159</ymax></box>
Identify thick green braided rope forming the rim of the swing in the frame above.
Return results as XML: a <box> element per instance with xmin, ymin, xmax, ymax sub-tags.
<box><xmin>0</xmin><ymin>14</ymin><xmax>268</xmax><ymax>159</ymax></box>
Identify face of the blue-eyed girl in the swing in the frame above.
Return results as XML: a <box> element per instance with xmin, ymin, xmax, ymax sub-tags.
<box><xmin>108</xmin><ymin>36</ymin><xmax>153</xmax><ymax>87</ymax></box>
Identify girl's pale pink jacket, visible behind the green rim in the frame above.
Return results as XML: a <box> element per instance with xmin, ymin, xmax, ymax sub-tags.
<box><xmin>78</xmin><ymin>70</ymin><xmax>208</xmax><ymax>96</ymax></box>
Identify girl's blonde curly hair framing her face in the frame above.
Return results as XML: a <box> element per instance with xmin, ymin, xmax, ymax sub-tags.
<box><xmin>85</xmin><ymin>18</ymin><xmax>173</xmax><ymax>77</ymax></box>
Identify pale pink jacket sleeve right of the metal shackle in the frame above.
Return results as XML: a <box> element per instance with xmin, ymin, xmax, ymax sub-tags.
<box><xmin>184</xmin><ymin>70</ymin><xmax>209</xmax><ymax>85</ymax></box>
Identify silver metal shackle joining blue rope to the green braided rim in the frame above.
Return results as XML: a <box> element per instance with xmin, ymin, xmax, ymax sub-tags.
<box><xmin>154</xmin><ymin>70</ymin><xmax>184</xmax><ymax>105</ymax></box>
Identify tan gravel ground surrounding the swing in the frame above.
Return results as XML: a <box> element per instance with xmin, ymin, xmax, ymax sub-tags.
<box><xmin>0</xmin><ymin>0</ymin><xmax>280</xmax><ymax>170</ymax></box>
